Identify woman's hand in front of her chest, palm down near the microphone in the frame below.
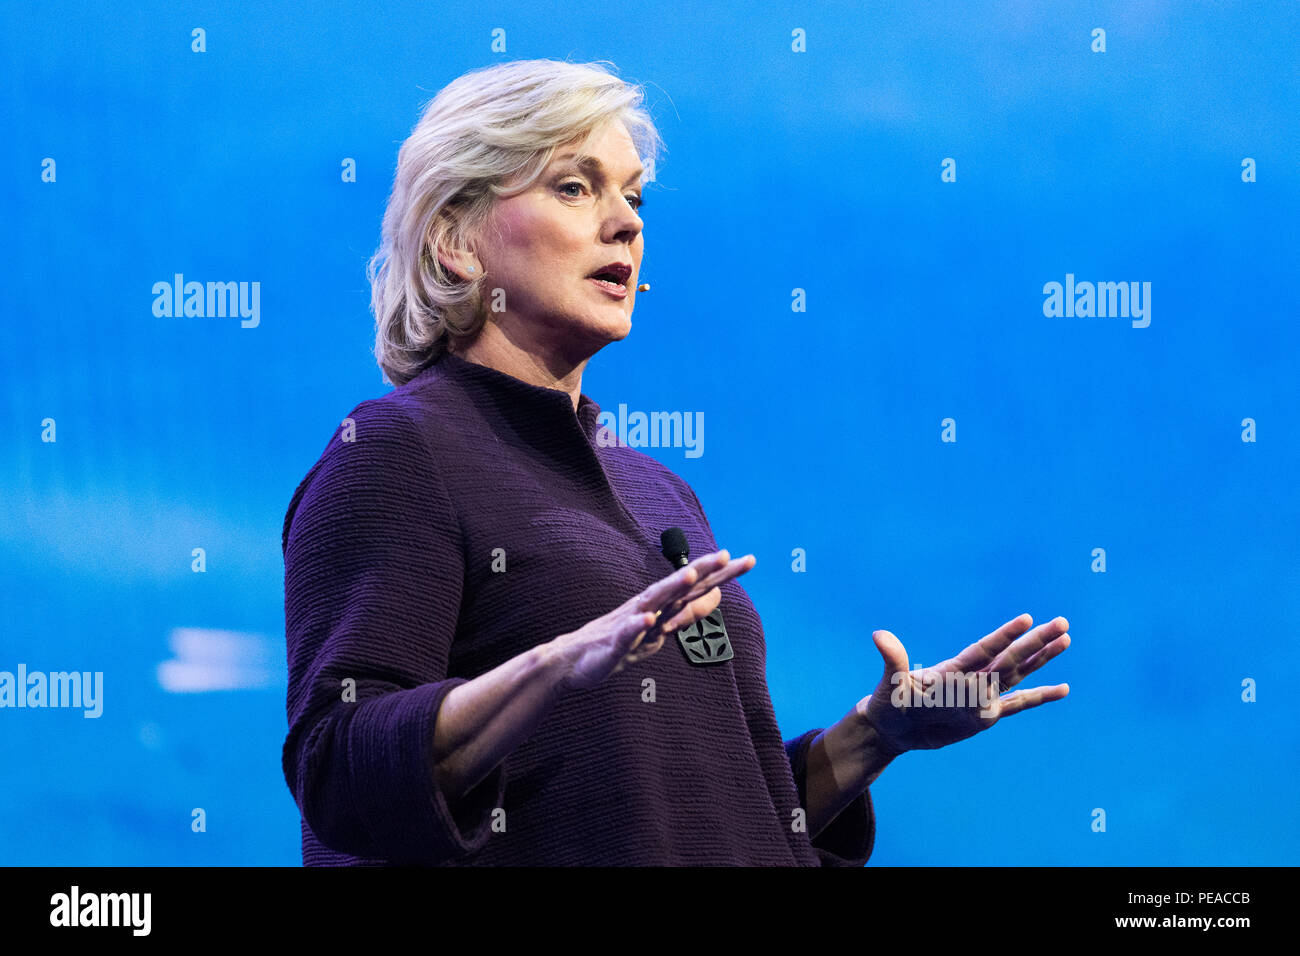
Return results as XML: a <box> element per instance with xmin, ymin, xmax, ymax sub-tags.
<box><xmin>547</xmin><ymin>550</ymin><xmax>757</xmax><ymax>689</ymax></box>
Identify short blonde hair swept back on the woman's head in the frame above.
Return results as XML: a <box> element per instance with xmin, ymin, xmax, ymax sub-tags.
<box><xmin>367</xmin><ymin>60</ymin><xmax>663</xmax><ymax>385</ymax></box>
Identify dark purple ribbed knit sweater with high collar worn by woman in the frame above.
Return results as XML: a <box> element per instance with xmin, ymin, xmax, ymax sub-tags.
<box><xmin>282</xmin><ymin>355</ymin><xmax>875</xmax><ymax>866</ymax></box>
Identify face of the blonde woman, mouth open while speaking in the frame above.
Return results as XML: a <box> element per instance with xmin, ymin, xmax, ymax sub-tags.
<box><xmin>473</xmin><ymin>122</ymin><xmax>645</xmax><ymax>364</ymax></box>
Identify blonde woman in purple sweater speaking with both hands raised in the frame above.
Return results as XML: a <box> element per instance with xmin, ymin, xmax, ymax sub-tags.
<box><xmin>282</xmin><ymin>61</ymin><xmax>1069</xmax><ymax>865</ymax></box>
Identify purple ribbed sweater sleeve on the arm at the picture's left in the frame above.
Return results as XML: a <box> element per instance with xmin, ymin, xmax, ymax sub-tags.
<box><xmin>282</xmin><ymin>401</ymin><xmax>504</xmax><ymax>865</ymax></box>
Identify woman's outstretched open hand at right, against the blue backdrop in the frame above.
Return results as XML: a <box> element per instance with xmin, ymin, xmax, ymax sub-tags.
<box><xmin>855</xmin><ymin>614</ymin><xmax>1070</xmax><ymax>754</ymax></box>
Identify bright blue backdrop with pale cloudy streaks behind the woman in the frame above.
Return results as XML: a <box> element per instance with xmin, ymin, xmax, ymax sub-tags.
<box><xmin>0</xmin><ymin>1</ymin><xmax>1300</xmax><ymax>865</ymax></box>
